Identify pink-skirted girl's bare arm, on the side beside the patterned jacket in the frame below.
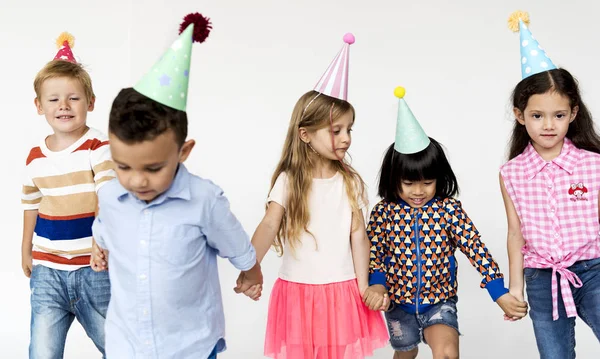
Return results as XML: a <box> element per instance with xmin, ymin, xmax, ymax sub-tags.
<box><xmin>350</xmin><ymin>211</ymin><xmax>371</xmax><ymax>296</ymax></box>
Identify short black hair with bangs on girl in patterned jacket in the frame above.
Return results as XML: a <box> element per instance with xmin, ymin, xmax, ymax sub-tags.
<box><xmin>378</xmin><ymin>137</ymin><xmax>459</xmax><ymax>202</ymax></box>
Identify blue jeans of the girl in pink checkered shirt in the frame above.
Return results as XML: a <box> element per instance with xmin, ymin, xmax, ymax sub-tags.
<box><xmin>525</xmin><ymin>258</ymin><xmax>600</xmax><ymax>359</ymax></box>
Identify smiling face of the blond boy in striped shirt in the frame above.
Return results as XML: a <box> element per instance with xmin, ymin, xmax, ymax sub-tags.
<box><xmin>35</xmin><ymin>77</ymin><xmax>95</xmax><ymax>134</ymax></box>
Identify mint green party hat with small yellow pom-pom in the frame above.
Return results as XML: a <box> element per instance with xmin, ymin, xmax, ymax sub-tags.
<box><xmin>394</xmin><ymin>87</ymin><xmax>431</xmax><ymax>154</ymax></box>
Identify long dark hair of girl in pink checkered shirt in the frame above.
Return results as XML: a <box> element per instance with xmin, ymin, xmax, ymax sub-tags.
<box><xmin>508</xmin><ymin>69</ymin><xmax>600</xmax><ymax>160</ymax></box>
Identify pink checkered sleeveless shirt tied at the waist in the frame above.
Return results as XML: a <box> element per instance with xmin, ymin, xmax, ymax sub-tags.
<box><xmin>500</xmin><ymin>138</ymin><xmax>600</xmax><ymax>320</ymax></box>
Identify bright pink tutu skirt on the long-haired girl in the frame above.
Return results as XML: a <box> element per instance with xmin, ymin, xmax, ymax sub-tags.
<box><xmin>265</xmin><ymin>279</ymin><xmax>389</xmax><ymax>359</ymax></box>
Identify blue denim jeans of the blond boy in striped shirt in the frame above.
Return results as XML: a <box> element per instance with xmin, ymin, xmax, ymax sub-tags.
<box><xmin>29</xmin><ymin>265</ymin><xmax>110</xmax><ymax>359</ymax></box>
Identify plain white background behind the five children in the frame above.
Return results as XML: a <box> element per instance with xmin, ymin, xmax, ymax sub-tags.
<box><xmin>0</xmin><ymin>0</ymin><xmax>600</xmax><ymax>359</ymax></box>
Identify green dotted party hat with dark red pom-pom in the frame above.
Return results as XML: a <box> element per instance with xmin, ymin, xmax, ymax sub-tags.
<box><xmin>133</xmin><ymin>13</ymin><xmax>212</xmax><ymax>111</ymax></box>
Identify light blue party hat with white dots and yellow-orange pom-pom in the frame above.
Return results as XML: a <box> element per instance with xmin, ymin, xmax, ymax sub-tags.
<box><xmin>508</xmin><ymin>11</ymin><xmax>556</xmax><ymax>78</ymax></box>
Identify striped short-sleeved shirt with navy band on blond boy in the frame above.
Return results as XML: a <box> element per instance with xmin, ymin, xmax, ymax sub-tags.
<box><xmin>21</xmin><ymin>128</ymin><xmax>115</xmax><ymax>270</ymax></box>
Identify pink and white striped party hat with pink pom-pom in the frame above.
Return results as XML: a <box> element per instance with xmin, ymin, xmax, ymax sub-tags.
<box><xmin>314</xmin><ymin>33</ymin><xmax>355</xmax><ymax>101</ymax></box>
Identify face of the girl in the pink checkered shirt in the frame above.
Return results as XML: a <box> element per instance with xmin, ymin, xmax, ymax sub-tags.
<box><xmin>514</xmin><ymin>91</ymin><xmax>579</xmax><ymax>155</ymax></box>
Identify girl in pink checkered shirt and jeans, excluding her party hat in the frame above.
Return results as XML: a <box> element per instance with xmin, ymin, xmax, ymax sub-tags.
<box><xmin>500</xmin><ymin>68</ymin><xmax>600</xmax><ymax>359</ymax></box>
